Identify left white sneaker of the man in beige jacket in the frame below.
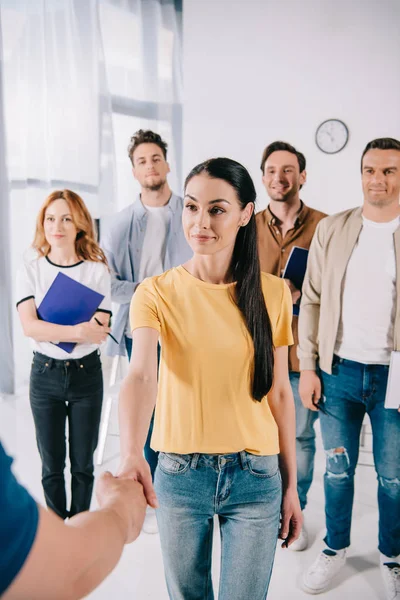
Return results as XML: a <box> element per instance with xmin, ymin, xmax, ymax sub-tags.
<box><xmin>303</xmin><ymin>548</ymin><xmax>346</xmax><ymax>594</ymax></box>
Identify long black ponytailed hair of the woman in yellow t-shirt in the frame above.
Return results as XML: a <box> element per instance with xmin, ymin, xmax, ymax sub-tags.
<box><xmin>185</xmin><ymin>158</ymin><xmax>274</xmax><ymax>402</ymax></box>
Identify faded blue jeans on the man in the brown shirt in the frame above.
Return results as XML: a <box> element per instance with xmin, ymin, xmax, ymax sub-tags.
<box><xmin>289</xmin><ymin>371</ymin><xmax>318</xmax><ymax>510</ymax></box>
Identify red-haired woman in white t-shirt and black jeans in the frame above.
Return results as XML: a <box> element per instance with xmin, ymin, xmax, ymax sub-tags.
<box><xmin>17</xmin><ymin>190</ymin><xmax>111</xmax><ymax>519</ymax></box>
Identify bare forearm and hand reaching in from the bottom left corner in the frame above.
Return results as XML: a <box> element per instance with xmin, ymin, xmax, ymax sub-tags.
<box><xmin>2</xmin><ymin>473</ymin><xmax>146</xmax><ymax>600</ymax></box>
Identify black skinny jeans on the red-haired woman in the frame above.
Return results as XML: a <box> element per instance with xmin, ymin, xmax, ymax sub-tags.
<box><xmin>29</xmin><ymin>351</ymin><xmax>103</xmax><ymax>519</ymax></box>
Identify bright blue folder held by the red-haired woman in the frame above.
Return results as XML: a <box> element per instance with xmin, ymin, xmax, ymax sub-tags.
<box><xmin>37</xmin><ymin>272</ymin><xmax>104</xmax><ymax>354</ymax></box>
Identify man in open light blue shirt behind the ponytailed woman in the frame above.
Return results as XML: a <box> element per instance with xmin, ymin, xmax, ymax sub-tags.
<box><xmin>102</xmin><ymin>129</ymin><xmax>192</xmax><ymax>533</ymax></box>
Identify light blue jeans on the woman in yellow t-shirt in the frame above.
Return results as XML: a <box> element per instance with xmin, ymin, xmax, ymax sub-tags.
<box><xmin>155</xmin><ymin>451</ymin><xmax>282</xmax><ymax>600</ymax></box>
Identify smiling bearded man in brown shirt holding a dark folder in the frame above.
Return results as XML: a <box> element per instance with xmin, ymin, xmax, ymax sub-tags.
<box><xmin>256</xmin><ymin>141</ymin><xmax>326</xmax><ymax>551</ymax></box>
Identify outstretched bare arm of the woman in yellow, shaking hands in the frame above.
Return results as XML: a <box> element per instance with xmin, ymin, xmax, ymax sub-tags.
<box><xmin>118</xmin><ymin>327</ymin><xmax>159</xmax><ymax>508</ymax></box>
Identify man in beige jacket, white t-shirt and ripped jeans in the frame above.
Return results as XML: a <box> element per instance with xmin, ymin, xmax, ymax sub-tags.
<box><xmin>298</xmin><ymin>138</ymin><xmax>400</xmax><ymax>600</ymax></box>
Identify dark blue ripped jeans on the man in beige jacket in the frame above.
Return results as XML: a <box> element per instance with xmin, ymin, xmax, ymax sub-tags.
<box><xmin>319</xmin><ymin>356</ymin><xmax>400</xmax><ymax>557</ymax></box>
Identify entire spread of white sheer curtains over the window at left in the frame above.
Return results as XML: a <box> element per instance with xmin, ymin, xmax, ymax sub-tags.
<box><xmin>0</xmin><ymin>0</ymin><xmax>182</xmax><ymax>387</ymax></box>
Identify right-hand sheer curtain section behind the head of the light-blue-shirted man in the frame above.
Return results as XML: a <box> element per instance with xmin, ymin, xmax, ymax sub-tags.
<box><xmin>99</xmin><ymin>0</ymin><xmax>182</xmax><ymax>208</ymax></box>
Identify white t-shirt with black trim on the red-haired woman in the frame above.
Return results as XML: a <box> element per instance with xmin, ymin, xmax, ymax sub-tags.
<box><xmin>17</xmin><ymin>256</ymin><xmax>111</xmax><ymax>360</ymax></box>
